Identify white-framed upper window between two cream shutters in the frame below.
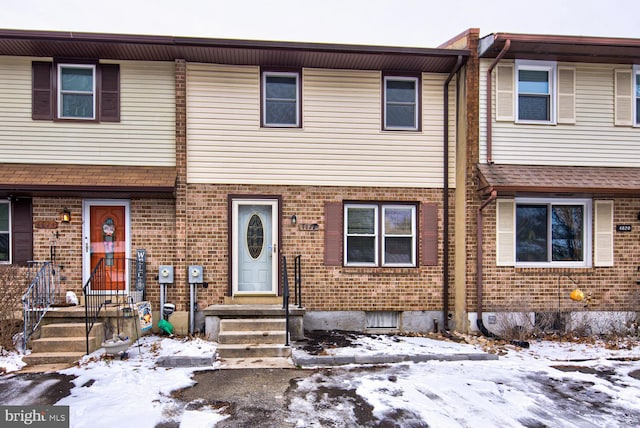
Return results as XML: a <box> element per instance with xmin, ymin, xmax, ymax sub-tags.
<box><xmin>516</xmin><ymin>60</ymin><xmax>556</xmax><ymax>123</ymax></box>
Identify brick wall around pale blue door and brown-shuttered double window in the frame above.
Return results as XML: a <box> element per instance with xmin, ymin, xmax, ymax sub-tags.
<box><xmin>177</xmin><ymin>184</ymin><xmax>454</xmax><ymax>310</ymax></box>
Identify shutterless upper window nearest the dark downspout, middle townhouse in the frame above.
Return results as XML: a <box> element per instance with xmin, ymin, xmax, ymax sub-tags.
<box><xmin>383</xmin><ymin>76</ymin><xmax>420</xmax><ymax>131</ymax></box>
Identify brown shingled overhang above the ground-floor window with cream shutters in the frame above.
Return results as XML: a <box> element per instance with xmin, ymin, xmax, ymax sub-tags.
<box><xmin>478</xmin><ymin>164</ymin><xmax>640</xmax><ymax>196</ymax></box>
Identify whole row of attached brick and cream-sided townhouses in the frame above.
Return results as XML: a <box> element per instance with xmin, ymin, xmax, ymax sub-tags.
<box><xmin>0</xmin><ymin>25</ymin><xmax>640</xmax><ymax>339</ymax></box>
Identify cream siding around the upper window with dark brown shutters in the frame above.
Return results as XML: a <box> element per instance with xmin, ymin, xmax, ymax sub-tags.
<box><xmin>0</xmin><ymin>57</ymin><xmax>175</xmax><ymax>166</ymax></box>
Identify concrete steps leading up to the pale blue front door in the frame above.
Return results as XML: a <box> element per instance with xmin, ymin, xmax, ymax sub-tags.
<box><xmin>217</xmin><ymin>318</ymin><xmax>291</xmax><ymax>359</ymax></box>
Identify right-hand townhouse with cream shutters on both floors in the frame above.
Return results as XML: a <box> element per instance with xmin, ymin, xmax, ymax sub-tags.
<box><xmin>466</xmin><ymin>33</ymin><xmax>640</xmax><ymax>333</ymax></box>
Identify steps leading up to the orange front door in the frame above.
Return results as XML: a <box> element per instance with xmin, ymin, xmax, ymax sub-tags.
<box><xmin>22</xmin><ymin>322</ymin><xmax>103</xmax><ymax>366</ymax></box>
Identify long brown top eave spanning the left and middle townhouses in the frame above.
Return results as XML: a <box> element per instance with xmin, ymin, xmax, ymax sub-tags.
<box><xmin>0</xmin><ymin>30</ymin><xmax>469</xmax><ymax>73</ymax></box>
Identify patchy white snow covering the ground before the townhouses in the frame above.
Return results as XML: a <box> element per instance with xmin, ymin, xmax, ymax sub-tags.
<box><xmin>0</xmin><ymin>336</ymin><xmax>640</xmax><ymax>428</ymax></box>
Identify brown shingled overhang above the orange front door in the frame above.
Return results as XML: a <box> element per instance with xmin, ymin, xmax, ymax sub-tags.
<box><xmin>0</xmin><ymin>163</ymin><xmax>176</xmax><ymax>198</ymax></box>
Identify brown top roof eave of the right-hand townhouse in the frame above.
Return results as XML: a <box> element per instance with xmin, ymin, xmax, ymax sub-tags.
<box><xmin>478</xmin><ymin>33</ymin><xmax>640</xmax><ymax>64</ymax></box>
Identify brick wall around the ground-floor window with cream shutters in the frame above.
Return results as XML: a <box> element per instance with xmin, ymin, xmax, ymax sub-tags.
<box><xmin>476</xmin><ymin>198</ymin><xmax>640</xmax><ymax>311</ymax></box>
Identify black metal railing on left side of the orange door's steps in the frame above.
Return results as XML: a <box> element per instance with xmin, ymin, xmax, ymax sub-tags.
<box><xmin>22</xmin><ymin>261</ymin><xmax>59</xmax><ymax>351</ymax></box>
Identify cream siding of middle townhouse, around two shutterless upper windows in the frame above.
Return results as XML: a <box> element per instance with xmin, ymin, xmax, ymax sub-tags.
<box><xmin>187</xmin><ymin>63</ymin><xmax>456</xmax><ymax>188</ymax></box>
